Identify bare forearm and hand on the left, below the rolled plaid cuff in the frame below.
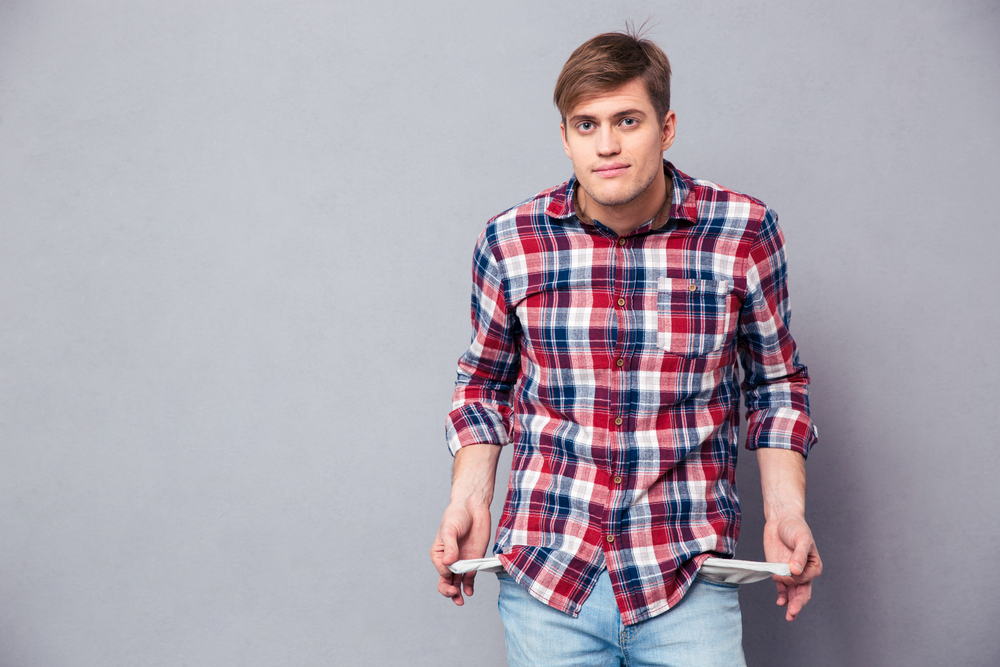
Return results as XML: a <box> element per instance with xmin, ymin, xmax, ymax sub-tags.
<box><xmin>431</xmin><ymin>445</ymin><xmax>500</xmax><ymax>606</ymax></box>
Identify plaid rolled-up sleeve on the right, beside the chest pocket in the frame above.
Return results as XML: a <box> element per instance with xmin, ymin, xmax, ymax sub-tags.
<box><xmin>739</xmin><ymin>209</ymin><xmax>817</xmax><ymax>456</ymax></box>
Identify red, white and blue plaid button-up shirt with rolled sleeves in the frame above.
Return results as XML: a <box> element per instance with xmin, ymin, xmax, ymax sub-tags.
<box><xmin>447</xmin><ymin>162</ymin><xmax>816</xmax><ymax>625</ymax></box>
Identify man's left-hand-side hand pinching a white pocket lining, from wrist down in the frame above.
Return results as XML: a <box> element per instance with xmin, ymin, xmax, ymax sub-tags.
<box><xmin>431</xmin><ymin>501</ymin><xmax>490</xmax><ymax>606</ymax></box>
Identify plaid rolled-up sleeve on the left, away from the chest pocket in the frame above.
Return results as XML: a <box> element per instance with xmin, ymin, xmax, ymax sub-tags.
<box><xmin>446</xmin><ymin>227</ymin><xmax>520</xmax><ymax>454</ymax></box>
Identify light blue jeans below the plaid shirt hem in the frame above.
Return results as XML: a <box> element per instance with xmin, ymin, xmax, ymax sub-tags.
<box><xmin>497</xmin><ymin>570</ymin><xmax>746</xmax><ymax>667</ymax></box>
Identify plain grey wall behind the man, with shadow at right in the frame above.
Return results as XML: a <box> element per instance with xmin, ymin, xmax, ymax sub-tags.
<box><xmin>0</xmin><ymin>0</ymin><xmax>1000</xmax><ymax>667</ymax></box>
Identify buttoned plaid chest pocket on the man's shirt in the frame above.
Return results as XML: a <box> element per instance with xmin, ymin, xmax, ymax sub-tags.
<box><xmin>656</xmin><ymin>276</ymin><xmax>736</xmax><ymax>357</ymax></box>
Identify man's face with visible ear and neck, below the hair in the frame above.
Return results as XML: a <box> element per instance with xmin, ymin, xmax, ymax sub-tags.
<box><xmin>559</xmin><ymin>79</ymin><xmax>676</xmax><ymax>217</ymax></box>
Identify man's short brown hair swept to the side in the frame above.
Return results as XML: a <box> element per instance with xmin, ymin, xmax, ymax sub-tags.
<box><xmin>552</xmin><ymin>28</ymin><xmax>670</xmax><ymax>122</ymax></box>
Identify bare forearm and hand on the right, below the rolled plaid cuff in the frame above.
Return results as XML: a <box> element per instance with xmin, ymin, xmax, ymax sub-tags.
<box><xmin>757</xmin><ymin>449</ymin><xmax>823</xmax><ymax>621</ymax></box>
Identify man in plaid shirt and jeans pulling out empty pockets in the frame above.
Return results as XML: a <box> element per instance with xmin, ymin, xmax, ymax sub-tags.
<box><xmin>431</xmin><ymin>33</ymin><xmax>822</xmax><ymax>667</ymax></box>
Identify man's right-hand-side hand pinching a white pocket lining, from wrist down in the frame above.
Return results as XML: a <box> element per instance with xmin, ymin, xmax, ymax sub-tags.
<box><xmin>764</xmin><ymin>516</ymin><xmax>823</xmax><ymax>621</ymax></box>
